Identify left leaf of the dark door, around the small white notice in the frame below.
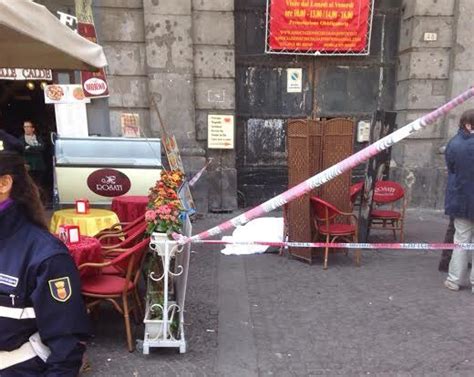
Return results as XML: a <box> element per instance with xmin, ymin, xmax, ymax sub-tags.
<box><xmin>235</xmin><ymin>0</ymin><xmax>313</xmax><ymax>206</ymax></box>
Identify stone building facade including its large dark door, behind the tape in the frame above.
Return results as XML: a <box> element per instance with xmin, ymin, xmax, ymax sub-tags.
<box><xmin>38</xmin><ymin>0</ymin><xmax>474</xmax><ymax>212</ymax></box>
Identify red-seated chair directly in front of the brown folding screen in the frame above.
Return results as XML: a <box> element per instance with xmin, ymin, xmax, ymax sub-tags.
<box><xmin>310</xmin><ymin>196</ymin><xmax>360</xmax><ymax>270</ymax></box>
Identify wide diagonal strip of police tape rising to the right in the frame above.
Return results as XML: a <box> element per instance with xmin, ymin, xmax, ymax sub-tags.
<box><xmin>184</xmin><ymin>88</ymin><xmax>474</xmax><ymax>243</ymax></box>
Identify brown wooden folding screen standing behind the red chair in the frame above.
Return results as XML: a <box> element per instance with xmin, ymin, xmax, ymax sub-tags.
<box><xmin>285</xmin><ymin>118</ymin><xmax>355</xmax><ymax>263</ymax></box>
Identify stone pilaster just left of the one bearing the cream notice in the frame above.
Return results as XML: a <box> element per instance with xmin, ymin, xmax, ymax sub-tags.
<box><xmin>143</xmin><ymin>0</ymin><xmax>207</xmax><ymax>211</ymax></box>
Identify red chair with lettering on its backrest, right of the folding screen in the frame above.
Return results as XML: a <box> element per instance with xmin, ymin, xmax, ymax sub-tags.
<box><xmin>369</xmin><ymin>181</ymin><xmax>406</xmax><ymax>242</ymax></box>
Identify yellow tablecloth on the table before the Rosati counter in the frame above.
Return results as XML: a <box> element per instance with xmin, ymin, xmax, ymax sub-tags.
<box><xmin>49</xmin><ymin>208</ymin><xmax>119</xmax><ymax>236</ymax></box>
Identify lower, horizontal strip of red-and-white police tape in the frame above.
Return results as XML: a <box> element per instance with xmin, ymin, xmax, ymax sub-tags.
<box><xmin>191</xmin><ymin>239</ymin><xmax>474</xmax><ymax>250</ymax></box>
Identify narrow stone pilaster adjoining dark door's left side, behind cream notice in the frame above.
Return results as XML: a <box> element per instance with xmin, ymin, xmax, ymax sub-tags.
<box><xmin>193</xmin><ymin>0</ymin><xmax>237</xmax><ymax>212</ymax></box>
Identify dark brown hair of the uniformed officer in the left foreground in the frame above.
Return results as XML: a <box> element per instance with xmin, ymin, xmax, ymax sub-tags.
<box><xmin>0</xmin><ymin>153</ymin><xmax>48</xmax><ymax>230</ymax></box>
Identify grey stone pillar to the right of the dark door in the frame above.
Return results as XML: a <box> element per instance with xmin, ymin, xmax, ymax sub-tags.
<box><xmin>392</xmin><ymin>0</ymin><xmax>474</xmax><ymax>208</ymax></box>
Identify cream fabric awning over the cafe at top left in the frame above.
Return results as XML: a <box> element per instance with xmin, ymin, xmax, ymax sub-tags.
<box><xmin>0</xmin><ymin>0</ymin><xmax>107</xmax><ymax>71</ymax></box>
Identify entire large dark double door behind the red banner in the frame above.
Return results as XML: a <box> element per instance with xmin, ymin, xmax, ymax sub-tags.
<box><xmin>234</xmin><ymin>0</ymin><xmax>402</xmax><ymax>206</ymax></box>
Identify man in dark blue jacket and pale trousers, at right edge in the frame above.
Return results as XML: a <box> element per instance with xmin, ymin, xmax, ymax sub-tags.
<box><xmin>444</xmin><ymin>110</ymin><xmax>474</xmax><ymax>292</ymax></box>
